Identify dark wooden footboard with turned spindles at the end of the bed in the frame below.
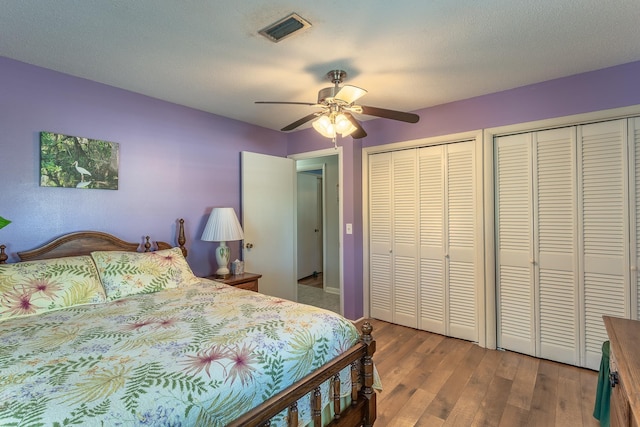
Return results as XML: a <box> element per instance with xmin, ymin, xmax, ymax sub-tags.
<box><xmin>229</xmin><ymin>322</ymin><xmax>376</xmax><ymax>427</ymax></box>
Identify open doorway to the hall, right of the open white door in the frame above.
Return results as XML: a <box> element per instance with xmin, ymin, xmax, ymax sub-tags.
<box><xmin>296</xmin><ymin>154</ymin><xmax>342</xmax><ymax>313</ymax></box>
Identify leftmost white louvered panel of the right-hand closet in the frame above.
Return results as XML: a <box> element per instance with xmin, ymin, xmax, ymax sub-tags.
<box><xmin>494</xmin><ymin>134</ymin><xmax>536</xmax><ymax>356</ymax></box>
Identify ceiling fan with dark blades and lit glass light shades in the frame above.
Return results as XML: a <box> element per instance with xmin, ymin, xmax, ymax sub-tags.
<box><xmin>256</xmin><ymin>70</ymin><xmax>420</xmax><ymax>144</ymax></box>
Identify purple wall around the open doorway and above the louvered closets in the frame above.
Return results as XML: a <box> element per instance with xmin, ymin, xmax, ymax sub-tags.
<box><xmin>289</xmin><ymin>61</ymin><xmax>640</xmax><ymax>319</ymax></box>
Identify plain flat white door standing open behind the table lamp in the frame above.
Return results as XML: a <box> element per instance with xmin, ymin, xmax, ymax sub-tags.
<box><xmin>241</xmin><ymin>151</ymin><xmax>297</xmax><ymax>301</ymax></box>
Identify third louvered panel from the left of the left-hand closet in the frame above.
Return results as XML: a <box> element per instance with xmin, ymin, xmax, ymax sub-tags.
<box><xmin>418</xmin><ymin>145</ymin><xmax>448</xmax><ymax>335</ymax></box>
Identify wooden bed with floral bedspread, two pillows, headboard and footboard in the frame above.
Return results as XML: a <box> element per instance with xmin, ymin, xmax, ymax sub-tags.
<box><xmin>0</xmin><ymin>220</ymin><xmax>377</xmax><ymax>426</ymax></box>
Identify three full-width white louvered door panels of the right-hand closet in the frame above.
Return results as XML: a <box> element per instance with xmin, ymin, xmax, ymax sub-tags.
<box><xmin>496</xmin><ymin>120</ymin><xmax>629</xmax><ymax>369</ymax></box>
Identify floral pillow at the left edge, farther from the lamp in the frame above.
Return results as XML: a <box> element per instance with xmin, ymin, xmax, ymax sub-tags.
<box><xmin>0</xmin><ymin>256</ymin><xmax>106</xmax><ymax>320</ymax></box>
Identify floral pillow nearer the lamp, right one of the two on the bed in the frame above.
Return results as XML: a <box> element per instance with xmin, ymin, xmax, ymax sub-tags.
<box><xmin>91</xmin><ymin>248</ymin><xmax>198</xmax><ymax>301</ymax></box>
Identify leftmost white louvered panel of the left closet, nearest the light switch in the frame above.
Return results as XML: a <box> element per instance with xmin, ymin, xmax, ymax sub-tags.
<box><xmin>369</xmin><ymin>153</ymin><xmax>393</xmax><ymax>322</ymax></box>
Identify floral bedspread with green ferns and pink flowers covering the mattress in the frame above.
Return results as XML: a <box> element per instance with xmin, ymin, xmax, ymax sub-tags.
<box><xmin>0</xmin><ymin>280</ymin><xmax>358</xmax><ymax>426</ymax></box>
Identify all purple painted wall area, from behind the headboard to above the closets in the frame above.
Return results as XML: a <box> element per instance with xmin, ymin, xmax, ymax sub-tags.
<box><xmin>0</xmin><ymin>58</ymin><xmax>640</xmax><ymax>319</ymax></box>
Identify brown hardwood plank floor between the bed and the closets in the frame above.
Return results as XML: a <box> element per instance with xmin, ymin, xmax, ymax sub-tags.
<box><xmin>358</xmin><ymin>319</ymin><xmax>600</xmax><ymax>427</ymax></box>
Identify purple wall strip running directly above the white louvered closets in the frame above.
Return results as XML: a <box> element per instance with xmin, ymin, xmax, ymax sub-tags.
<box><xmin>363</xmin><ymin>61</ymin><xmax>640</xmax><ymax>147</ymax></box>
